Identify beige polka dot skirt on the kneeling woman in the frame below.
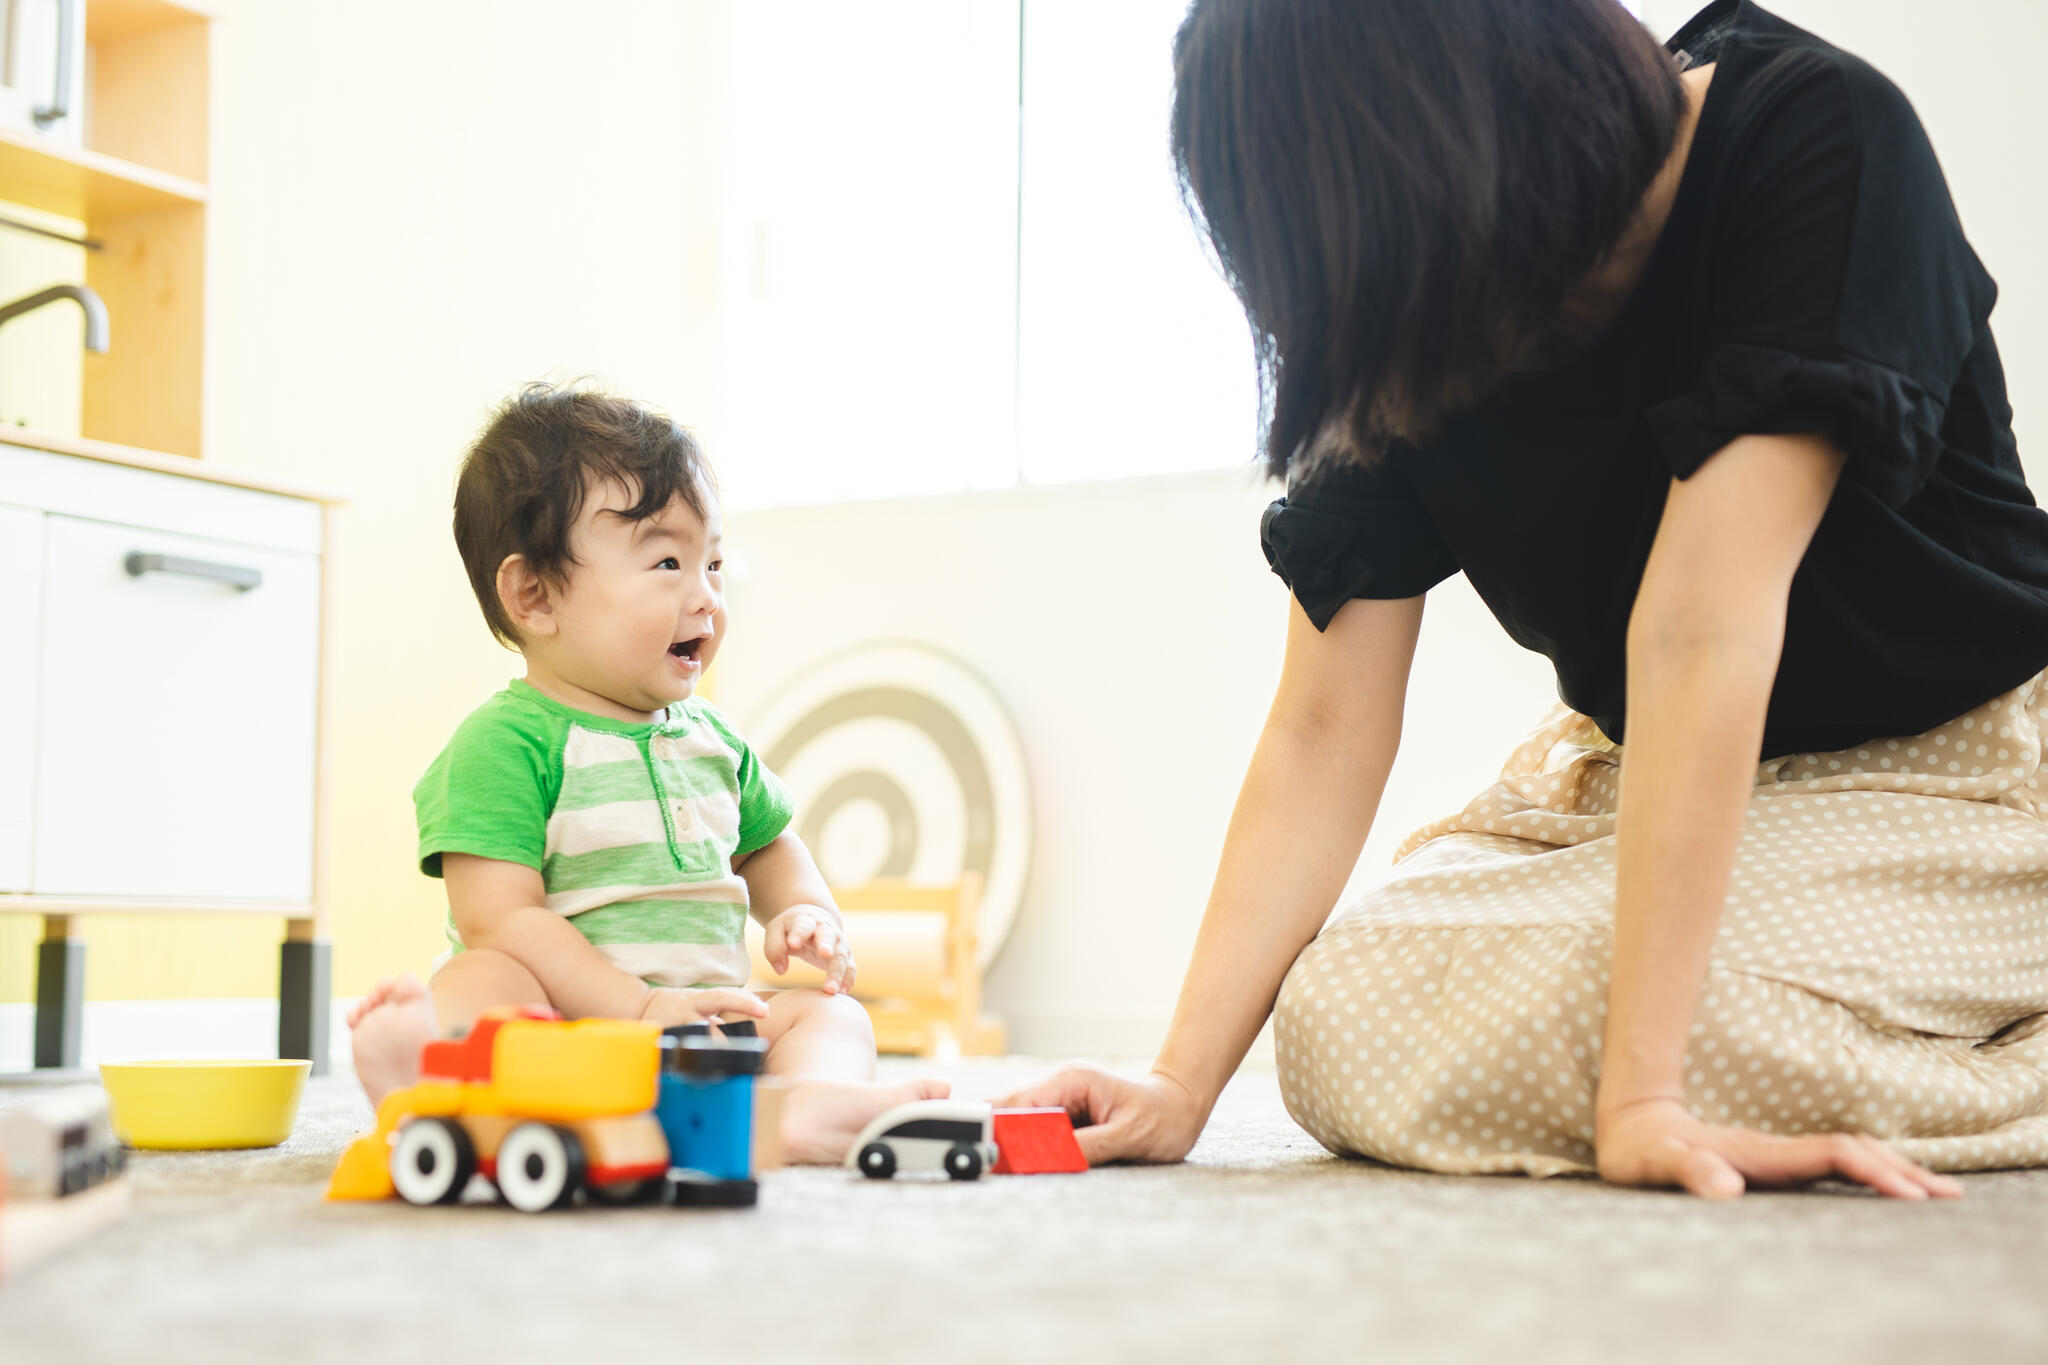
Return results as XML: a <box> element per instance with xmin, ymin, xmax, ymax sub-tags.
<box><xmin>1274</xmin><ymin>673</ymin><xmax>2048</xmax><ymax>1175</ymax></box>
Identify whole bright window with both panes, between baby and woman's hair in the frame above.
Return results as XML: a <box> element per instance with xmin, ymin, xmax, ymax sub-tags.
<box><xmin>719</xmin><ymin>0</ymin><xmax>1257</xmax><ymax>505</ymax></box>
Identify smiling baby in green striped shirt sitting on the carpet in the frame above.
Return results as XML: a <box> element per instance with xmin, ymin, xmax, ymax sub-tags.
<box><xmin>348</xmin><ymin>385</ymin><xmax>946</xmax><ymax>1162</ymax></box>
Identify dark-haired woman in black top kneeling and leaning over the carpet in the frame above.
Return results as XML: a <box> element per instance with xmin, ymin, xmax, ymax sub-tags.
<box><xmin>1016</xmin><ymin>0</ymin><xmax>2048</xmax><ymax>1199</ymax></box>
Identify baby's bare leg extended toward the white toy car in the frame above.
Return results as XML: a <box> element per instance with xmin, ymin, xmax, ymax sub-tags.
<box><xmin>760</xmin><ymin>990</ymin><xmax>950</xmax><ymax>1164</ymax></box>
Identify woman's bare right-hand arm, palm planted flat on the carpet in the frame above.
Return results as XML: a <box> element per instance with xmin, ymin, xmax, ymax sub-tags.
<box><xmin>1595</xmin><ymin>436</ymin><xmax>1950</xmax><ymax>1197</ymax></box>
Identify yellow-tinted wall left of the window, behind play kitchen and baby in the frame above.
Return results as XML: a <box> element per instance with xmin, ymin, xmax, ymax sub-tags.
<box><xmin>0</xmin><ymin>0</ymin><xmax>727</xmax><ymax>1035</ymax></box>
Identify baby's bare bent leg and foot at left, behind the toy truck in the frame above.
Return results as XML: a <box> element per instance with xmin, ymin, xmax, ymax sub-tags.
<box><xmin>348</xmin><ymin>948</ymin><xmax>547</xmax><ymax>1105</ymax></box>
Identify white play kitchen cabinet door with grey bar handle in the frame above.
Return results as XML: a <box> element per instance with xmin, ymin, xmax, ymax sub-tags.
<box><xmin>31</xmin><ymin>516</ymin><xmax>319</xmax><ymax>900</ymax></box>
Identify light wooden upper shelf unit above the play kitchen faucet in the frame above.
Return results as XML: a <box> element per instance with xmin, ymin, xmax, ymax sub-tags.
<box><xmin>0</xmin><ymin>0</ymin><xmax>211</xmax><ymax>456</ymax></box>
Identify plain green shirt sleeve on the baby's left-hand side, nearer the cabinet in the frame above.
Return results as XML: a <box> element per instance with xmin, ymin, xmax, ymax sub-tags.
<box><xmin>412</xmin><ymin>696</ymin><xmax>561</xmax><ymax>876</ymax></box>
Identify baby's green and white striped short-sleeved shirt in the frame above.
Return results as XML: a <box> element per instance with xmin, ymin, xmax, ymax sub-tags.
<box><xmin>412</xmin><ymin>681</ymin><xmax>791</xmax><ymax>986</ymax></box>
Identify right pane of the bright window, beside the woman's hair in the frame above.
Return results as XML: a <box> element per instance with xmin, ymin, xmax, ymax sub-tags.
<box><xmin>1018</xmin><ymin>0</ymin><xmax>1257</xmax><ymax>483</ymax></box>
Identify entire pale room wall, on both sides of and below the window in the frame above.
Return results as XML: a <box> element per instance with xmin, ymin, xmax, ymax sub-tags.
<box><xmin>0</xmin><ymin>0</ymin><xmax>2048</xmax><ymax>1068</ymax></box>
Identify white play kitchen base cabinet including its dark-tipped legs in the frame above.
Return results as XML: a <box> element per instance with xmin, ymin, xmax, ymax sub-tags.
<box><xmin>0</xmin><ymin>434</ymin><xmax>332</xmax><ymax>1070</ymax></box>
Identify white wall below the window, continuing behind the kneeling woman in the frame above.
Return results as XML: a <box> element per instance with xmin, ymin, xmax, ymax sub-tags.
<box><xmin>719</xmin><ymin>0</ymin><xmax>2048</xmax><ymax>1054</ymax></box>
